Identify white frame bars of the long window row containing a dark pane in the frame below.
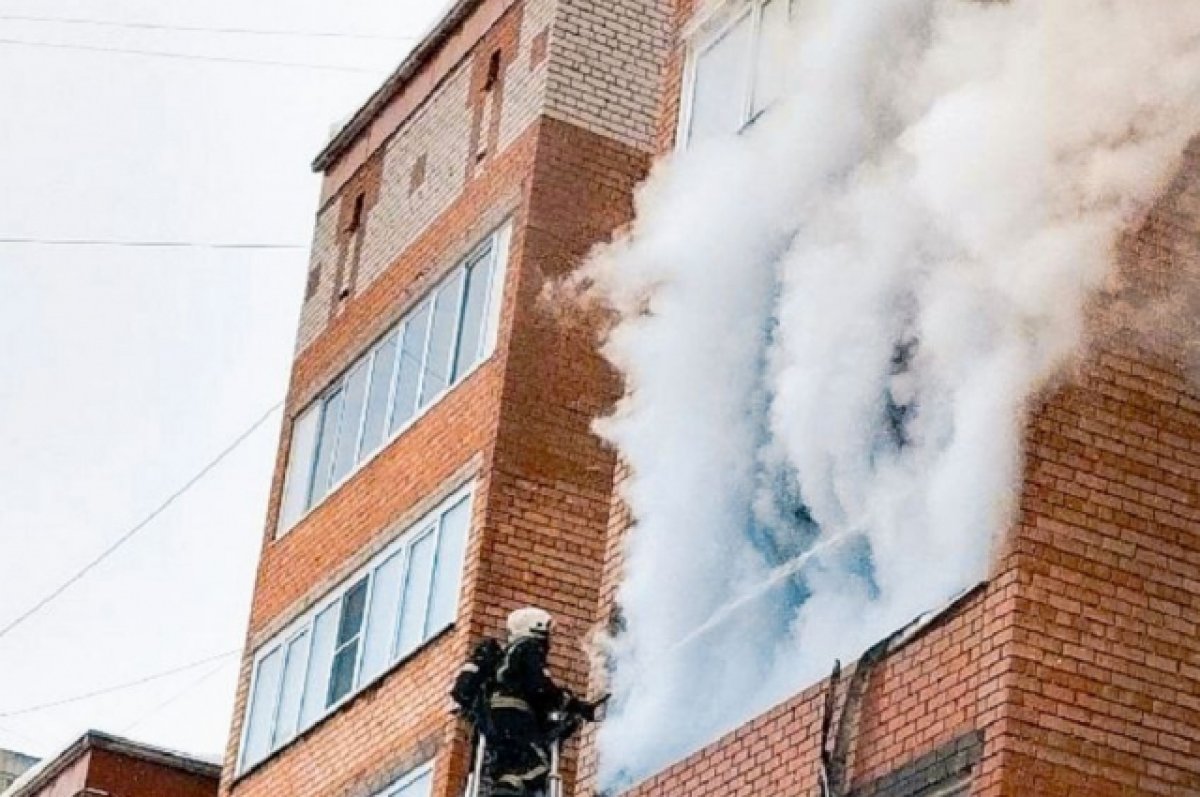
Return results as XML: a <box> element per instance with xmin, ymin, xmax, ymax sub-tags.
<box><xmin>236</xmin><ymin>483</ymin><xmax>475</xmax><ymax>777</ymax></box>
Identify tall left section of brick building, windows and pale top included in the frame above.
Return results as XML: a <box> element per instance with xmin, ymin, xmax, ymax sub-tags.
<box><xmin>222</xmin><ymin>0</ymin><xmax>670</xmax><ymax>797</ymax></box>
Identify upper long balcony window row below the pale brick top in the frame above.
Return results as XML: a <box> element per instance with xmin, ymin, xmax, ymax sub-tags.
<box><xmin>278</xmin><ymin>227</ymin><xmax>509</xmax><ymax>534</ymax></box>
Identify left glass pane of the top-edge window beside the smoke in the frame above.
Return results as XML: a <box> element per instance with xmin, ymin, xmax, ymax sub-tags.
<box><xmin>688</xmin><ymin>13</ymin><xmax>754</xmax><ymax>144</ymax></box>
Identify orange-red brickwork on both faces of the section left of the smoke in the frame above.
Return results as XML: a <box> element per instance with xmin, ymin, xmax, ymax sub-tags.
<box><xmin>223</xmin><ymin>69</ymin><xmax>648</xmax><ymax>796</ymax></box>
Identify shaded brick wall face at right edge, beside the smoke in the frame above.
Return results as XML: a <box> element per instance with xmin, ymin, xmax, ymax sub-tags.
<box><xmin>1006</xmin><ymin>139</ymin><xmax>1200</xmax><ymax>796</ymax></box>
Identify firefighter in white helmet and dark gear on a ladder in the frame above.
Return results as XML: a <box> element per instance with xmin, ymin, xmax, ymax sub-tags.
<box><xmin>456</xmin><ymin>606</ymin><xmax>599</xmax><ymax>797</ymax></box>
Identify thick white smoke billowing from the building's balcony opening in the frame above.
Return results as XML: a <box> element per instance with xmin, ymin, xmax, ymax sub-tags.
<box><xmin>587</xmin><ymin>0</ymin><xmax>1200</xmax><ymax>785</ymax></box>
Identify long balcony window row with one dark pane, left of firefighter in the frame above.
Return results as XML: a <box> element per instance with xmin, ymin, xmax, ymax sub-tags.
<box><xmin>238</xmin><ymin>489</ymin><xmax>472</xmax><ymax>772</ymax></box>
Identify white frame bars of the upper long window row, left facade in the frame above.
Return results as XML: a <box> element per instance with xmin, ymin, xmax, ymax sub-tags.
<box><xmin>275</xmin><ymin>220</ymin><xmax>512</xmax><ymax>539</ymax></box>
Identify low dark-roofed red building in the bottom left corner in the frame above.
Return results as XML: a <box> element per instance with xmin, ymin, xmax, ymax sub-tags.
<box><xmin>4</xmin><ymin>731</ymin><xmax>221</xmax><ymax>797</ymax></box>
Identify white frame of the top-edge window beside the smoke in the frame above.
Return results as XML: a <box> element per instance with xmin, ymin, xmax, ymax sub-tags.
<box><xmin>676</xmin><ymin>0</ymin><xmax>797</xmax><ymax>150</ymax></box>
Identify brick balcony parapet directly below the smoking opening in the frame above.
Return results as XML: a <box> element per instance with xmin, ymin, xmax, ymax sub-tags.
<box><xmin>609</xmin><ymin>585</ymin><xmax>1014</xmax><ymax>797</ymax></box>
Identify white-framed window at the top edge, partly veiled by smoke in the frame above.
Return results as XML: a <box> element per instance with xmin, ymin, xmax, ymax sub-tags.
<box><xmin>680</xmin><ymin>0</ymin><xmax>794</xmax><ymax>145</ymax></box>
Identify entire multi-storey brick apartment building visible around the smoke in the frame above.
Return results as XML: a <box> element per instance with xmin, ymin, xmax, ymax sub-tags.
<box><xmin>221</xmin><ymin>0</ymin><xmax>1200</xmax><ymax>797</ymax></box>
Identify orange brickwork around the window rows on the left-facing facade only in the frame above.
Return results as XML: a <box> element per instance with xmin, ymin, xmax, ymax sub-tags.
<box><xmin>224</xmin><ymin>112</ymin><xmax>536</xmax><ymax>795</ymax></box>
